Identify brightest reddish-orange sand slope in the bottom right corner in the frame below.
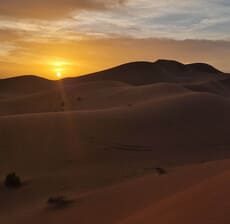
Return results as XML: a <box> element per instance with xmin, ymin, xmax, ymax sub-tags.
<box><xmin>121</xmin><ymin>170</ymin><xmax>230</xmax><ymax>224</ymax></box>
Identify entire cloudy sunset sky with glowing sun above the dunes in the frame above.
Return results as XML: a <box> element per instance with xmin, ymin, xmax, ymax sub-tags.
<box><xmin>0</xmin><ymin>0</ymin><xmax>230</xmax><ymax>79</ymax></box>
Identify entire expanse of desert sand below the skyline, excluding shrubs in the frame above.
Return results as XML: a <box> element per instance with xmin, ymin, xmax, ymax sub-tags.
<box><xmin>0</xmin><ymin>60</ymin><xmax>230</xmax><ymax>224</ymax></box>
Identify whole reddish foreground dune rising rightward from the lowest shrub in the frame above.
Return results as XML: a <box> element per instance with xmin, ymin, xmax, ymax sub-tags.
<box><xmin>3</xmin><ymin>160</ymin><xmax>230</xmax><ymax>224</ymax></box>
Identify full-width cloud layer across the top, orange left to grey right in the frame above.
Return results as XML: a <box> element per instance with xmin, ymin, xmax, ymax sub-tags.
<box><xmin>0</xmin><ymin>0</ymin><xmax>230</xmax><ymax>41</ymax></box>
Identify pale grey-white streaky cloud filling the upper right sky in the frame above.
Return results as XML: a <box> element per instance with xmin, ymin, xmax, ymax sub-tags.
<box><xmin>74</xmin><ymin>0</ymin><xmax>230</xmax><ymax>40</ymax></box>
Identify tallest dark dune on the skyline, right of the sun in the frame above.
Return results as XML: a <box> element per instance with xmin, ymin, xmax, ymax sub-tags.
<box><xmin>65</xmin><ymin>60</ymin><xmax>224</xmax><ymax>85</ymax></box>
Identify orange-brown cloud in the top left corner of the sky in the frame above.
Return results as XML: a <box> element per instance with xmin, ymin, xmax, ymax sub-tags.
<box><xmin>0</xmin><ymin>0</ymin><xmax>124</xmax><ymax>19</ymax></box>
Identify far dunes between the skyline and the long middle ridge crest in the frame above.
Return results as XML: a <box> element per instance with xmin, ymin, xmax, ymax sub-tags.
<box><xmin>0</xmin><ymin>60</ymin><xmax>227</xmax><ymax>115</ymax></box>
